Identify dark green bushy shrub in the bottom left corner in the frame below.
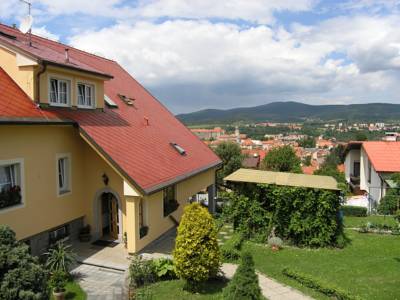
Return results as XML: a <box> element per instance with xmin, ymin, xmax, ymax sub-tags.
<box><xmin>0</xmin><ymin>226</ymin><xmax>48</xmax><ymax>300</ymax></box>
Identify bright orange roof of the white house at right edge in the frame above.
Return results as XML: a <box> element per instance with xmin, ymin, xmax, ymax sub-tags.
<box><xmin>362</xmin><ymin>141</ymin><xmax>400</xmax><ymax>172</ymax></box>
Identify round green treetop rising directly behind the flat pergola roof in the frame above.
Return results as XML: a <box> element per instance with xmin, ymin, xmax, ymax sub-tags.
<box><xmin>262</xmin><ymin>145</ymin><xmax>302</xmax><ymax>173</ymax></box>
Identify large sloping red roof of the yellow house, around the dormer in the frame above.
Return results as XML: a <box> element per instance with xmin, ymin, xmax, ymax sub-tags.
<box><xmin>0</xmin><ymin>24</ymin><xmax>221</xmax><ymax>193</ymax></box>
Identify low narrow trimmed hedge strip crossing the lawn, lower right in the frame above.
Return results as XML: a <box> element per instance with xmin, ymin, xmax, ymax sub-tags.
<box><xmin>282</xmin><ymin>268</ymin><xmax>361</xmax><ymax>300</ymax></box>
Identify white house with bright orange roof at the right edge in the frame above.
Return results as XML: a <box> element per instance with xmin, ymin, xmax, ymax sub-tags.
<box><xmin>345</xmin><ymin>141</ymin><xmax>400</xmax><ymax>205</ymax></box>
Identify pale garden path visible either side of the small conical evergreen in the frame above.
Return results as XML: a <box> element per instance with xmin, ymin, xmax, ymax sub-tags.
<box><xmin>222</xmin><ymin>263</ymin><xmax>313</xmax><ymax>300</ymax></box>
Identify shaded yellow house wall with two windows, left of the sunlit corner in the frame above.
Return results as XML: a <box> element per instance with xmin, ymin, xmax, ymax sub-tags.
<box><xmin>0</xmin><ymin>125</ymin><xmax>125</xmax><ymax>239</ymax></box>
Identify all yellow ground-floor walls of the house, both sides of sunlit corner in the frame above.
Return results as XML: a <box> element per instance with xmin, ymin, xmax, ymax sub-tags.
<box><xmin>0</xmin><ymin>125</ymin><xmax>215</xmax><ymax>253</ymax></box>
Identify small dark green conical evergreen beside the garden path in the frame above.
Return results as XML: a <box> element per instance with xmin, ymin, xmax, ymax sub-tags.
<box><xmin>223</xmin><ymin>252</ymin><xmax>262</xmax><ymax>300</ymax></box>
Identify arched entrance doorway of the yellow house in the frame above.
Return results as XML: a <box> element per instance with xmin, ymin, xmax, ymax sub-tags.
<box><xmin>93</xmin><ymin>188</ymin><xmax>122</xmax><ymax>242</ymax></box>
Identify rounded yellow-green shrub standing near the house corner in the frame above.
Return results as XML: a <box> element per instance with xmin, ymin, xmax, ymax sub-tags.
<box><xmin>173</xmin><ymin>203</ymin><xmax>220</xmax><ymax>288</ymax></box>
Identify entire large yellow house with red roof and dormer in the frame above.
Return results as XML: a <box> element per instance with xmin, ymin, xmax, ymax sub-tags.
<box><xmin>0</xmin><ymin>24</ymin><xmax>221</xmax><ymax>254</ymax></box>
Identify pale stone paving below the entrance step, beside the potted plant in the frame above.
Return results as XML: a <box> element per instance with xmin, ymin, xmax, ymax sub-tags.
<box><xmin>72</xmin><ymin>264</ymin><xmax>128</xmax><ymax>300</ymax></box>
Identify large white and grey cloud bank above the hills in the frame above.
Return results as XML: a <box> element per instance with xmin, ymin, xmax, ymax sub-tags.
<box><xmin>70</xmin><ymin>11</ymin><xmax>400</xmax><ymax>111</ymax></box>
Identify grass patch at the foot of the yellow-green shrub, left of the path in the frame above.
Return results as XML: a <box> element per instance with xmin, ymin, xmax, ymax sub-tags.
<box><xmin>137</xmin><ymin>278</ymin><xmax>227</xmax><ymax>300</ymax></box>
